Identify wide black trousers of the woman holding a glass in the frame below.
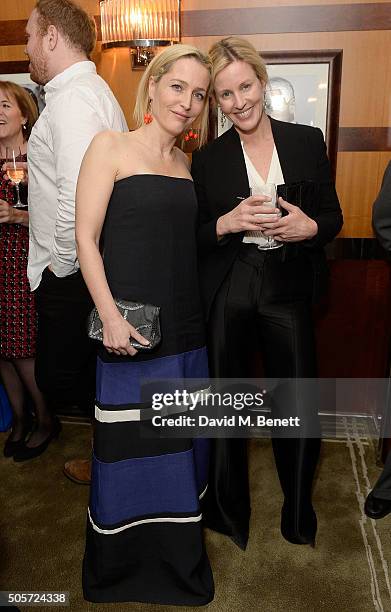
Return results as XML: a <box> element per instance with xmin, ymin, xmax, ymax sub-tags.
<box><xmin>204</xmin><ymin>244</ymin><xmax>320</xmax><ymax>548</ymax></box>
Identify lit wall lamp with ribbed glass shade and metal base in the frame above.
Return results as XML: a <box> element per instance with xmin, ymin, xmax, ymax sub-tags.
<box><xmin>100</xmin><ymin>0</ymin><xmax>181</xmax><ymax>70</ymax></box>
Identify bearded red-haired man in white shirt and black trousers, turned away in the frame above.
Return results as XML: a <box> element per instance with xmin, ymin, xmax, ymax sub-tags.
<box><xmin>26</xmin><ymin>0</ymin><xmax>128</xmax><ymax>468</ymax></box>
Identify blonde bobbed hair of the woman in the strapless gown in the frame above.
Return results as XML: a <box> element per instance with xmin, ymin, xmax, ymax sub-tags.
<box><xmin>133</xmin><ymin>44</ymin><xmax>212</xmax><ymax>146</ymax></box>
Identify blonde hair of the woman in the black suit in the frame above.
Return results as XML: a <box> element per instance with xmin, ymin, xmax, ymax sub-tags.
<box><xmin>209</xmin><ymin>36</ymin><xmax>268</xmax><ymax>86</ymax></box>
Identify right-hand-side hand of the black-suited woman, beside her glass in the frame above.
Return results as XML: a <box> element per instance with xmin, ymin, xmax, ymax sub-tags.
<box><xmin>260</xmin><ymin>198</ymin><xmax>318</xmax><ymax>242</ymax></box>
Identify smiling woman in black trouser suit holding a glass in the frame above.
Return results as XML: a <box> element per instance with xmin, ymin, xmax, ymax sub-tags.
<box><xmin>192</xmin><ymin>37</ymin><xmax>342</xmax><ymax>548</ymax></box>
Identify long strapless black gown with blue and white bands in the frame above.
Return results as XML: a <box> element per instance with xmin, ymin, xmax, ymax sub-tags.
<box><xmin>83</xmin><ymin>174</ymin><xmax>213</xmax><ymax>606</ymax></box>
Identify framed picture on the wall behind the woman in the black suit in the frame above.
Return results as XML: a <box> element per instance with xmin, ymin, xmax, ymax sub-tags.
<box><xmin>215</xmin><ymin>49</ymin><xmax>342</xmax><ymax>176</ymax></box>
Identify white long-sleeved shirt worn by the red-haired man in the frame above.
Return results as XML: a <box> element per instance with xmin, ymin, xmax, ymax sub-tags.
<box><xmin>27</xmin><ymin>61</ymin><xmax>128</xmax><ymax>291</ymax></box>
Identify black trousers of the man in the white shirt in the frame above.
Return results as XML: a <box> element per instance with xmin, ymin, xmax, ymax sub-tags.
<box><xmin>35</xmin><ymin>268</ymin><xmax>96</xmax><ymax>413</ymax></box>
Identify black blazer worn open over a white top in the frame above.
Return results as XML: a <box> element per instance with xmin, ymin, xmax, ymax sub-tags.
<box><xmin>191</xmin><ymin>118</ymin><xmax>343</xmax><ymax>317</ymax></box>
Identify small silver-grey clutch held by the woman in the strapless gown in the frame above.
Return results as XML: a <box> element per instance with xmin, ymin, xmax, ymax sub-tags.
<box><xmin>87</xmin><ymin>299</ymin><xmax>161</xmax><ymax>351</ymax></box>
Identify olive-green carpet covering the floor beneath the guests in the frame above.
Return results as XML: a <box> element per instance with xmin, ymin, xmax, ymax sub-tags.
<box><xmin>0</xmin><ymin>424</ymin><xmax>391</xmax><ymax>612</ymax></box>
